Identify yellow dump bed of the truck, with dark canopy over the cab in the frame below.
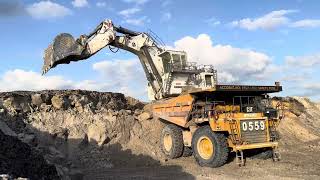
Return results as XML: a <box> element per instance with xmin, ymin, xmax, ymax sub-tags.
<box><xmin>152</xmin><ymin>83</ymin><xmax>282</xmax><ymax>127</ymax></box>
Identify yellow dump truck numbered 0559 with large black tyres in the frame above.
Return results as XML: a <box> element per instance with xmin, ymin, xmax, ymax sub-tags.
<box><xmin>152</xmin><ymin>83</ymin><xmax>282</xmax><ymax>167</ymax></box>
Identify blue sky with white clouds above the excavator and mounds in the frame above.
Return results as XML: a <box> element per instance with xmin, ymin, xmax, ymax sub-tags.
<box><xmin>0</xmin><ymin>0</ymin><xmax>320</xmax><ymax>101</ymax></box>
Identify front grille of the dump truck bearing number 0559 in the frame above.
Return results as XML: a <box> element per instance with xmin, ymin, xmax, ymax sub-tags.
<box><xmin>240</xmin><ymin>119</ymin><xmax>267</xmax><ymax>144</ymax></box>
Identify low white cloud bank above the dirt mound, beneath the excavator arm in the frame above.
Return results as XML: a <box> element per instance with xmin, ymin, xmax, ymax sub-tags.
<box><xmin>0</xmin><ymin>62</ymin><xmax>147</xmax><ymax>100</ymax></box>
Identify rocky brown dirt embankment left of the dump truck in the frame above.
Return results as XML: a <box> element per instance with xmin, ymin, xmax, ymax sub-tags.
<box><xmin>0</xmin><ymin>90</ymin><xmax>165</xmax><ymax>178</ymax></box>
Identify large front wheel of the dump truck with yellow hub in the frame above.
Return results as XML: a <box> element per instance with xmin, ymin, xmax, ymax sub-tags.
<box><xmin>192</xmin><ymin>126</ymin><xmax>229</xmax><ymax>167</ymax></box>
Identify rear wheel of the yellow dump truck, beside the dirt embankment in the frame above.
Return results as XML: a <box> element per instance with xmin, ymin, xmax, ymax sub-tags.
<box><xmin>161</xmin><ymin>124</ymin><xmax>184</xmax><ymax>159</ymax></box>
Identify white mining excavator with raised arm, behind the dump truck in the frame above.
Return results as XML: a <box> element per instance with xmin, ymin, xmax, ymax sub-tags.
<box><xmin>42</xmin><ymin>20</ymin><xmax>217</xmax><ymax>100</ymax></box>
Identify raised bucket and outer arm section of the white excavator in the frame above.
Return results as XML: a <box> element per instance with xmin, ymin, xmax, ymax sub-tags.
<box><xmin>42</xmin><ymin>20</ymin><xmax>115</xmax><ymax>74</ymax></box>
